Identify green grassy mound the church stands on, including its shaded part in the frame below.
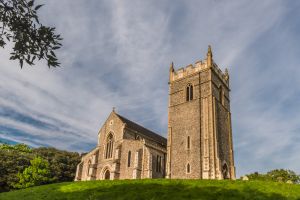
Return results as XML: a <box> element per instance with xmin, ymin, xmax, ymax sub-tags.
<box><xmin>0</xmin><ymin>179</ymin><xmax>300</xmax><ymax>200</ymax></box>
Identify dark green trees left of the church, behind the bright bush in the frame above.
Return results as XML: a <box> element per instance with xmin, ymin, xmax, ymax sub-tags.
<box><xmin>0</xmin><ymin>144</ymin><xmax>80</xmax><ymax>192</ymax></box>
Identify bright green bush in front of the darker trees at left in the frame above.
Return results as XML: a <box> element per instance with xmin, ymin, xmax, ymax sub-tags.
<box><xmin>14</xmin><ymin>157</ymin><xmax>52</xmax><ymax>188</ymax></box>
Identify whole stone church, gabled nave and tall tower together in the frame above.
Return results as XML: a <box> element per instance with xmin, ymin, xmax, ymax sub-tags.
<box><xmin>75</xmin><ymin>46</ymin><xmax>235</xmax><ymax>181</ymax></box>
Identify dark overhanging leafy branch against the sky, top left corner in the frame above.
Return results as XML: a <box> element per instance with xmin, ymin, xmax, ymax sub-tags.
<box><xmin>0</xmin><ymin>0</ymin><xmax>62</xmax><ymax>68</ymax></box>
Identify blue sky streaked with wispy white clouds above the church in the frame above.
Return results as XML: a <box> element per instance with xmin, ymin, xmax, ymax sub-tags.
<box><xmin>0</xmin><ymin>0</ymin><xmax>300</xmax><ymax>176</ymax></box>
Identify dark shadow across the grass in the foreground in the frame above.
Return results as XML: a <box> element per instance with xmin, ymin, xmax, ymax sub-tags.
<box><xmin>57</xmin><ymin>183</ymin><xmax>287</xmax><ymax>200</ymax></box>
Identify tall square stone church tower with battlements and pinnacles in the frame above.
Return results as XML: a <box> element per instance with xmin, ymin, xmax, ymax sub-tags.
<box><xmin>166</xmin><ymin>46</ymin><xmax>235</xmax><ymax>179</ymax></box>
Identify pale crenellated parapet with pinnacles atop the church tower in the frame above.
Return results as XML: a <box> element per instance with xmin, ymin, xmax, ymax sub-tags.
<box><xmin>169</xmin><ymin>46</ymin><xmax>229</xmax><ymax>87</ymax></box>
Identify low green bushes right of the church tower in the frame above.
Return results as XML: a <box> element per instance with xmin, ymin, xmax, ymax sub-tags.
<box><xmin>246</xmin><ymin>169</ymin><xmax>300</xmax><ymax>183</ymax></box>
